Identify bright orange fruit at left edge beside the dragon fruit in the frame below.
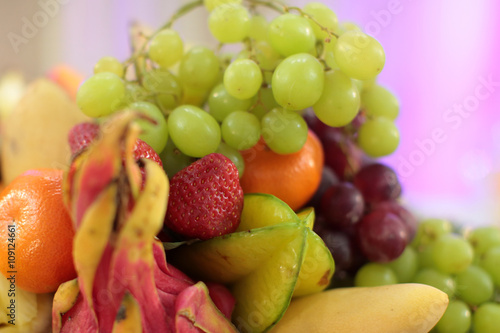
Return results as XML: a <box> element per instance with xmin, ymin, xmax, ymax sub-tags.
<box><xmin>0</xmin><ymin>169</ymin><xmax>76</xmax><ymax>293</ymax></box>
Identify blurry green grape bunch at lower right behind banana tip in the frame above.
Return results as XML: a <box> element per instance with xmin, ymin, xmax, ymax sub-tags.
<box><xmin>354</xmin><ymin>218</ymin><xmax>500</xmax><ymax>333</ymax></box>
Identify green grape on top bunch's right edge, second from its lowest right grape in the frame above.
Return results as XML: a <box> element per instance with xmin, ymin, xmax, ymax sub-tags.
<box><xmin>361</xmin><ymin>84</ymin><xmax>399</xmax><ymax>120</ymax></box>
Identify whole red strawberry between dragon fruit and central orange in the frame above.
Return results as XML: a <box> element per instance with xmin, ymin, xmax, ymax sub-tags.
<box><xmin>165</xmin><ymin>153</ymin><xmax>243</xmax><ymax>239</ymax></box>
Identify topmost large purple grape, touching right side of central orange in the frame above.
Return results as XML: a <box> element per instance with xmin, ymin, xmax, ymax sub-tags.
<box><xmin>322</xmin><ymin>128</ymin><xmax>364</xmax><ymax>180</ymax></box>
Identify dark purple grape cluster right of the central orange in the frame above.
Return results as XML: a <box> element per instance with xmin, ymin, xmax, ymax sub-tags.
<box><xmin>304</xmin><ymin>112</ymin><xmax>417</xmax><ymax>283</ymax></box>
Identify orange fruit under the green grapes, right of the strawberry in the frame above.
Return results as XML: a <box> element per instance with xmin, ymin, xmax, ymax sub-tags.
<box><xmin>240</xmin><ymin>131</ymin><xmax>324</xmax><ymax>210</ymax></box>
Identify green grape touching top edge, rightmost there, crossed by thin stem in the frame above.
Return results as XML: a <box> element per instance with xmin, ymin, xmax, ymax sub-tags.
<box><xmin>302</xmin><ymin>2</ymin><xmax>338</xmax><ymax>39</ymax></box>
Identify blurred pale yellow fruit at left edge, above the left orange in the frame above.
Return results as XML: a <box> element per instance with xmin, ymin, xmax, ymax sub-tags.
<box><xmin>1</xmin><ymin>78</ymin><xmax>89</xmax><ymax>184</ymax></box>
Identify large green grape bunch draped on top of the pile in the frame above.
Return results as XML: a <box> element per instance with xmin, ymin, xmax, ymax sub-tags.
<box><xmin>77</xmin><ymin>0</ymin><xmax>399</xmax><ymax>176</ymax></box>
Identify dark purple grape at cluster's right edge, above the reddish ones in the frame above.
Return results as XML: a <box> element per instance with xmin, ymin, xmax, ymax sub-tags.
<box><xmin>353</xmin><ymin>163</ymin><xmax>401</xmax><ymax>204</ymax></box>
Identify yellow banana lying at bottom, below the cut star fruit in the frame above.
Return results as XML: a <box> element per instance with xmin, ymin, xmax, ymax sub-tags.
<box><xmin>270</xmin><ymin>283</ymin><xmax>449</xmax><ymax>333</ymax></box>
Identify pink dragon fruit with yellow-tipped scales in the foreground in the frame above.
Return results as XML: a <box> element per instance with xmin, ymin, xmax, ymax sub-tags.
<box><xmin>52</xmin><ymin>112</ymin><xmax>237</xmax><ymax>333</ymax></box>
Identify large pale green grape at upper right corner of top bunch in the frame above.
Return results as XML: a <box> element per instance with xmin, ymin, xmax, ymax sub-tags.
<box><xmin>333</xmin><ymin>30</ymin><xmax>385</xmax><ymax>80</ymax></box>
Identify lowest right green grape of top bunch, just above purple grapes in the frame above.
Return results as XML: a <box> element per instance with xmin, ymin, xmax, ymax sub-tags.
<box><xmin>358</xmin><ymin>117</ymin><xmax>399</xmax><ymax>157</ymax></box>
